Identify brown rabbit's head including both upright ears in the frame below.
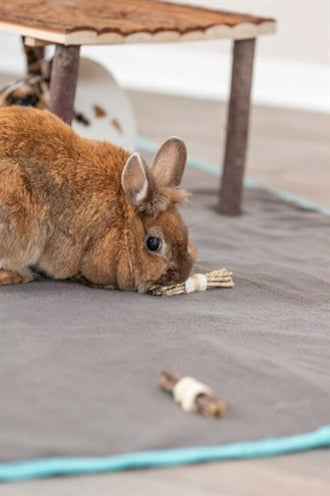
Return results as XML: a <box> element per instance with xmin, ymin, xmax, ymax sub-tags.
<box><xmin>121</xmin><ymin>137</ymin><xmax>197</xmax><ymax>292</ymax></box>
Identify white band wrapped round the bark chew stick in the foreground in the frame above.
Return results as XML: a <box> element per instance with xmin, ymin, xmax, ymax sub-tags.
<box><xmin>173</xmin><ymin>376</ymin><xmax>213</xmax><ymax>412</ymax></box>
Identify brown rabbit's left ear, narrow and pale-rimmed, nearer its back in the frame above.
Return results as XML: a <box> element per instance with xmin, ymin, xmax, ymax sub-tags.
<box><xmin>121</xmin><ymin>153</ymin><xmax>153</xmax><ymax>206</ymax></box>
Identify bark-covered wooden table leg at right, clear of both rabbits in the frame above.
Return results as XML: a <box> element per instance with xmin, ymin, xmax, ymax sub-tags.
<box><xmin>219</xmin><ymin>38</ymin><xmax>255</xmax><ymax>215</ymax></box>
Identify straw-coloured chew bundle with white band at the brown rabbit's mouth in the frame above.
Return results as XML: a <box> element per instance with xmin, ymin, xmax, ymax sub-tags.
<box><xmin>149</xmin><ymin>267</ymin><xmax>234</xmax><ymax>296</ymax></box>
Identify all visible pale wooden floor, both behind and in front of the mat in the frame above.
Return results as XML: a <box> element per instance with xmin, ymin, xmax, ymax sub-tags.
<box><xmin>1</xmin><ymin>92</ymin><xmax>330</xmax><ymax>496</ymax></box>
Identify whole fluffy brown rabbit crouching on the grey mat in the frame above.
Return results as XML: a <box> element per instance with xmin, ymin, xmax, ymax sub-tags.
<box><xmin>0</xmin><ymin>106</ymin><xmax>196</xmax><ymax>292</ymax></box>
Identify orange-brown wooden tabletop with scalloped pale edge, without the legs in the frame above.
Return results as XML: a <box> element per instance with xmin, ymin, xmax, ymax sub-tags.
<box><xmin>0</xmin><ymin>0</ymin><xmax>276</xmax><ymax>45</ymax></box>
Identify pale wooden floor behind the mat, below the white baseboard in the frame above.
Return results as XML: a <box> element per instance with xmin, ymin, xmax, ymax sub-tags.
<box><xmin>130</xmin><ymin>93</ymin><xmax>330</xmax><ymax>208</ymax></box>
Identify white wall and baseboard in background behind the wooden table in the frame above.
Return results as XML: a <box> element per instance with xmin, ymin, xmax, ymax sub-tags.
<box><xmin>0</xmin><ymin>0</ymin><xmax>329</xmax><ymax>112</ymax></box>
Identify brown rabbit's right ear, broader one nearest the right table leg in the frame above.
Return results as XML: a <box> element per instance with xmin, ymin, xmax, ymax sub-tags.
<box><xmin>151</xmin><ymin>136</ymin><xmax>187</xmax><ymax>186</ymax></box>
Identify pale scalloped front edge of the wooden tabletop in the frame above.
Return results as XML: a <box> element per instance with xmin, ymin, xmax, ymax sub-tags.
<box><xmin>0</xmin><ymin>21</ymin><xmax>276</xmax><ymax>46</ymax></box>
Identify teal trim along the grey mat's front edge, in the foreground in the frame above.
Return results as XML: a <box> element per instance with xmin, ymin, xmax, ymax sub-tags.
<box><xmin>0</xmin><ymin>425</ymin><xmax>330</xmax><ymax>481</ymax></box>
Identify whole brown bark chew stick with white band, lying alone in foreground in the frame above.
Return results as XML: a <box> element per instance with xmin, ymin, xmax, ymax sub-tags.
<box><xmin>159</xmin><ymin>369</ymin><xmax>226</xmax><ymax>418</ymax></box>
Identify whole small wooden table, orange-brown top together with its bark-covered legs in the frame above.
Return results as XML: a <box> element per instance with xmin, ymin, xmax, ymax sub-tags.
<box><xmin>0</xmin><ymin>0</ymin><xmax>276</xmax><ymax>215</ymax></box>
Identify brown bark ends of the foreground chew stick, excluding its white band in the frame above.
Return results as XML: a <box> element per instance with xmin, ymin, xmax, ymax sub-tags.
<box><xmin>159</xmin><ymin>369</ymin><xmax>226</xmax><ymax>418</ymax></box>
